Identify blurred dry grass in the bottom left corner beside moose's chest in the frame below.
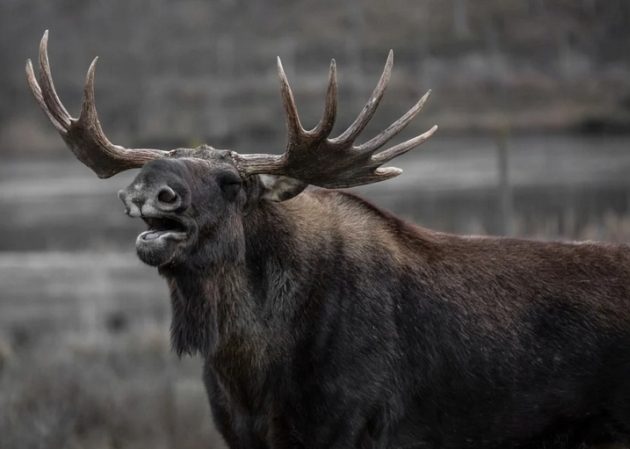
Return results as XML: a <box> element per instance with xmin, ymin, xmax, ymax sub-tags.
<box><xmin>0</xmin><ymin>330</ymin><xmax>227</xmax><ymax>449</ymax></box>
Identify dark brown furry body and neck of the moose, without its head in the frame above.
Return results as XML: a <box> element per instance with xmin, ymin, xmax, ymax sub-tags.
<box><xmin>160</xmin><ymin>178</ymin><xmax>630</xmax><ymax>448</ymax></box>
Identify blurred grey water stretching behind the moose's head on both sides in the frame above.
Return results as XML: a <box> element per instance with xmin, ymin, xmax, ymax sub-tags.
<box><xmin>0</xmin><ymin>134</ymin><xmax>630</xmax><ymax>252</ymax></box>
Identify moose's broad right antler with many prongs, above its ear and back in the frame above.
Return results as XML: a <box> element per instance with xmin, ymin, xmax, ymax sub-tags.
<box><xmin>232</xmin><ymin>50</ymin><xmax>437</xmax><ymax>188</ymax></box>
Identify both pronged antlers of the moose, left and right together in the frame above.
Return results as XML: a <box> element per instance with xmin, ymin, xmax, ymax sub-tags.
<box><xmin>26</xmin><ymin>30</ymin><xmax>437</xmax><ymax>188</ymax></box>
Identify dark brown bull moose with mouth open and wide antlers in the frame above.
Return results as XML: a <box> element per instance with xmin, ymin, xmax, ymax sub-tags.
<box><xmin>26</xmin><ymin>33</ymin><xmax>630</xmax><ymax>449</ymax></box>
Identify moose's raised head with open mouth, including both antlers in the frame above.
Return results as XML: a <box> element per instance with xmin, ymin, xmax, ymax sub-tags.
<box><xmin>26</xmin><ymin>31</ymin><xmax>437</xmax><ymax>267</ymax></box>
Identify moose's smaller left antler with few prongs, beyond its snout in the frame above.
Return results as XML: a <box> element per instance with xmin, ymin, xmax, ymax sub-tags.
<box><xmin>26</xmin><ymin>30</ymin><xmax>169</xmax><ymax>178</ymax></box>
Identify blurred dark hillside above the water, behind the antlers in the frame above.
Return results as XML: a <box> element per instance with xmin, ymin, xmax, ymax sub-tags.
<box><xmin>0</xmin><ymin>0</ymin><xmax>630</xmax><ymax>154</ymax></box>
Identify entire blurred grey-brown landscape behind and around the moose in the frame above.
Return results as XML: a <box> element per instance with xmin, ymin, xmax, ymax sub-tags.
<box><xmin>0</xmin><ymin>0</ymin><xmax>630</xmax><ymax>449</ymax></box>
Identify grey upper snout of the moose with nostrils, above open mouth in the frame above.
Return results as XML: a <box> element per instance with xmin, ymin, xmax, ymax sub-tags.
<box><xmin>118</xmin><ymin>183</ymin><xmax>182</xmax><ymax>217</ymax></box>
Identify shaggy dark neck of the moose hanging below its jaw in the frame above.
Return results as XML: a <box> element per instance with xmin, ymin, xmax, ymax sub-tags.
<box><xmin>161</xmin><ymin>196</ymin><xmax>304</xmax><ymax>366</ymax></box>
